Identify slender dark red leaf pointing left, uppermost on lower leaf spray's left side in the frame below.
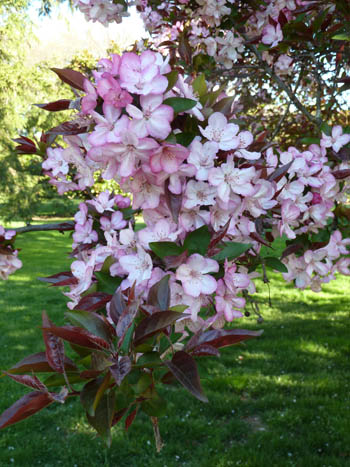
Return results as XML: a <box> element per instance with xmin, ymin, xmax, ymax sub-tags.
<box><xmin>43</xmin><ymin>325</ymin><xmax>109</xmax><ymax>350</ymax></box>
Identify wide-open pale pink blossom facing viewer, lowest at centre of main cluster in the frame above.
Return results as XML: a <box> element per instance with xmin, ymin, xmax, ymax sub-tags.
<box><xmin>176</xmin><ymin>253</ymin><xmax>219</xmax><ymax>297</ymax></box>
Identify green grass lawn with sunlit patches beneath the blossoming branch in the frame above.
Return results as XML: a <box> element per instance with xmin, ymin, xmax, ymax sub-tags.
<box><xmin>0</xmin><ymin>225</ymin><xmax>350</xmax><ymax>467</ymax></box>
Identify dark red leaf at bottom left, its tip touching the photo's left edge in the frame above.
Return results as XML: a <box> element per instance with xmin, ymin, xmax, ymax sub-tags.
<box><xmin>0</xmin><ymin>391</ymin><xmax>52</xmax><ymax>429</ymax></box>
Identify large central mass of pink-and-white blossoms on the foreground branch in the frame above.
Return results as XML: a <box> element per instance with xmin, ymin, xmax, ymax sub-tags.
<box><xmin>29</xmin><ymin>51</ymin><xmax>350</xmax><ymax>327</ymax></box>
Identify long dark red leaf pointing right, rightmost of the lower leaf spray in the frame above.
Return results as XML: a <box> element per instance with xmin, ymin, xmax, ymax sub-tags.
<box><xmin>186</xmin><ymin>329</ymin><xmax>263</xmax><ymax>350</ymax></box>
